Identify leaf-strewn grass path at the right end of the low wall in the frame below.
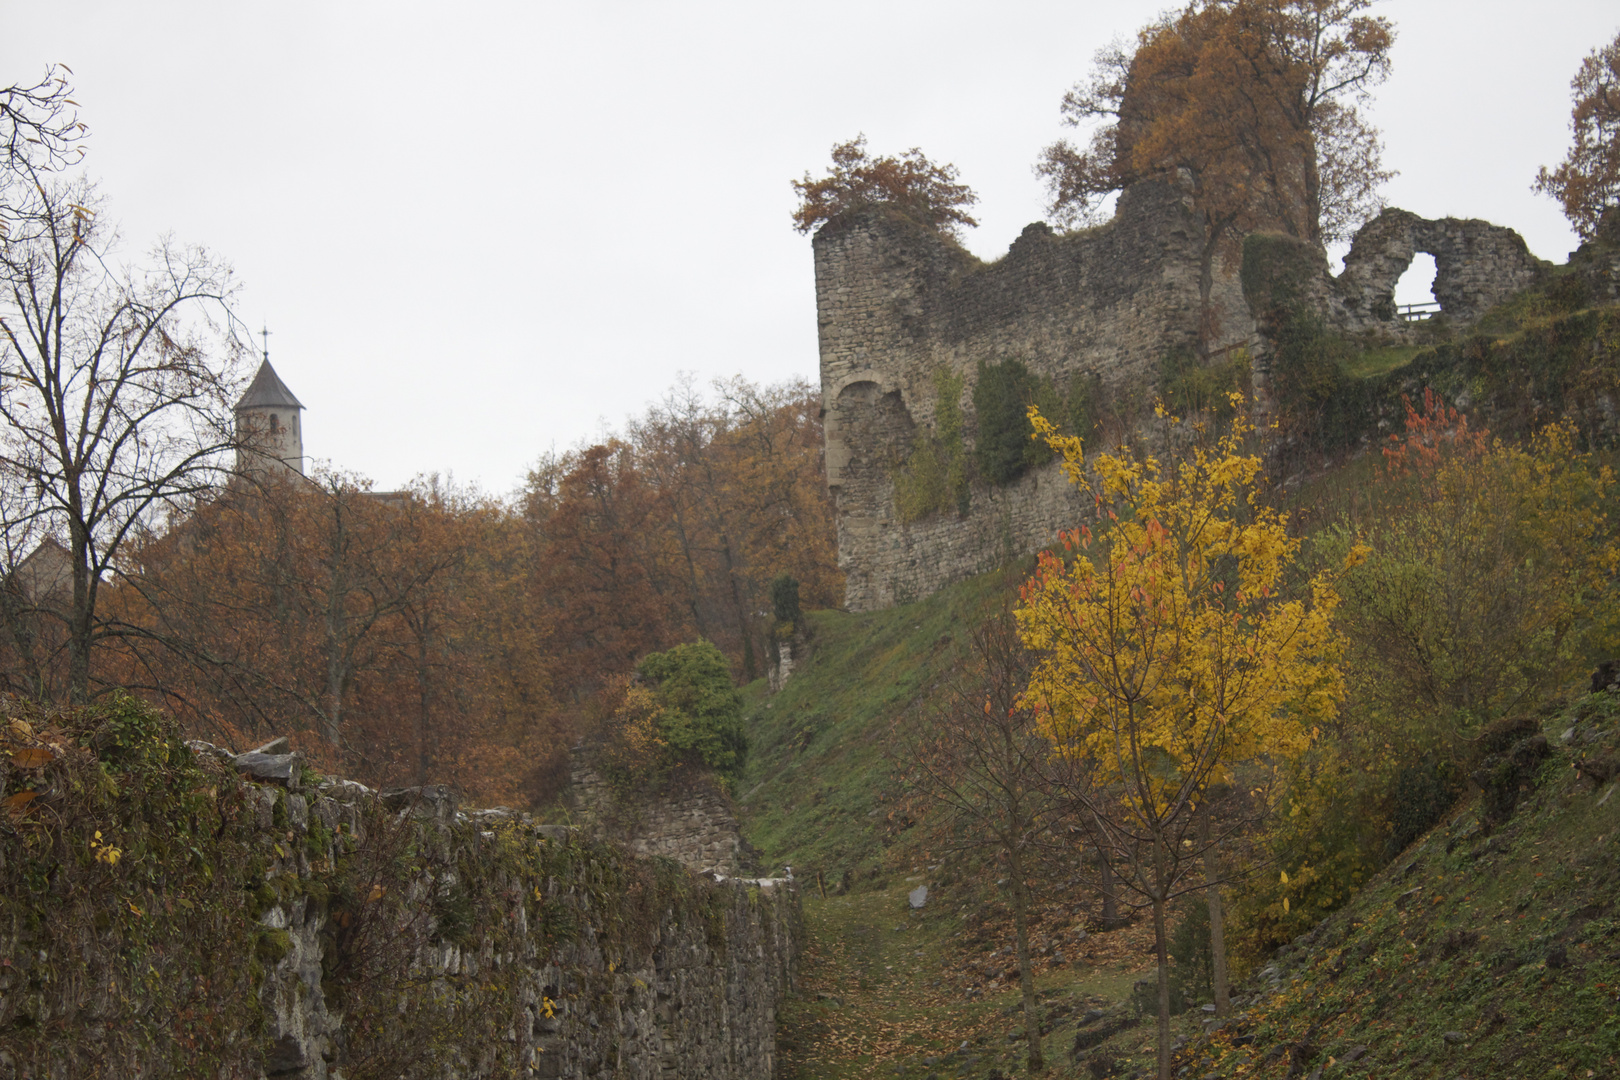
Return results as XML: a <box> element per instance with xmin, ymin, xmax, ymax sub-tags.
<box><xmin>778</xmin><ymin>876</ymin><xmax>1200</xmax><ymax>1080</ymax></box>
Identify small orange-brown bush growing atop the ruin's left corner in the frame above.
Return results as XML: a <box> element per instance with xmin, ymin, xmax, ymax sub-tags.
<box><xmin>792</xmin><ymin>134</ymin><xmax>978</xmax><ymax>236</ymax></box>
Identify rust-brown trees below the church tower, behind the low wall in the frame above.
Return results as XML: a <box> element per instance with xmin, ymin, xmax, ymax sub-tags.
<box><xmin>118</xmin><ymin>474</ymin><xmax>567</xmax><ymax>801</ymax></box>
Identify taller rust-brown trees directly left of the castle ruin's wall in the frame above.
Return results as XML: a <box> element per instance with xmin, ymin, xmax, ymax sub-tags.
<box><xmin>525</xmin><ymin>379</ymin><xmax>842</xmax><ymax>703</ymax></box>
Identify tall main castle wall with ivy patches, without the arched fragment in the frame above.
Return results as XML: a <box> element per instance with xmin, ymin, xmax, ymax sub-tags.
<box><xmin>815</xmin><ymin>183</ymin><xmax>1254</xmax><ymax>610</ymax></box>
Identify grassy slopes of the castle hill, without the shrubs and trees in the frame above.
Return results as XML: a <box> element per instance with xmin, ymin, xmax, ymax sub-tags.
<box><xmin>737</xmin><ymin>263</ymin><xmax>1620</xmax><ymax>1080</ymax></box>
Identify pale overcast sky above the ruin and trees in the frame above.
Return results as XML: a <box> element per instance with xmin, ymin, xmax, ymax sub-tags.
<box><xmin>0</xmin><ymin>0</ymin><xmax>1620</xmax><ymax>492</ymax></box>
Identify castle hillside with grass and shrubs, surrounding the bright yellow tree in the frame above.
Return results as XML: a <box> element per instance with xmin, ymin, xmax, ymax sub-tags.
<box><xmin>735</xmin><ymin>229</ymin><xmax>1620</xmax><ymax>1078</ymax></box>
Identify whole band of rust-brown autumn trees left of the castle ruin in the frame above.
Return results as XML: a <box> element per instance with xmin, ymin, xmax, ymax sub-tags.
<box><xmin>0</xmin><ymin>379</ymin><xmax>842</xmax><ymax>803</ymax></box>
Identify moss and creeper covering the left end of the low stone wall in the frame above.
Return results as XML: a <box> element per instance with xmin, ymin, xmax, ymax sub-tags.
<box><xmin>0</xmin><ymin>696</ymin><xmax>275</xmax><ymax>1077</ymax></box>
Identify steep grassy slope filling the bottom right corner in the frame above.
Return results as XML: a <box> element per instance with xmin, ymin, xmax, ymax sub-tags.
<box><xmin>1178</xmin><ymin>691</ymin><xmax>1620</xmax><ymax>1080</ymax></box>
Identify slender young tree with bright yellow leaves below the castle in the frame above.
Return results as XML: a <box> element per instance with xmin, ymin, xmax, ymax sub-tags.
<box><xmin>1017</xmin><ymin>395</ymin><xmax>1366</xmax><ymax>1080</ymax></box>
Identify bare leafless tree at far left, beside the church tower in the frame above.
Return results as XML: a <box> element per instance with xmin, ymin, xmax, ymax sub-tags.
<box><xmin>0</xmin><ymin>176</ymin><xmax>238</xmax><ymax>701</ymax></box>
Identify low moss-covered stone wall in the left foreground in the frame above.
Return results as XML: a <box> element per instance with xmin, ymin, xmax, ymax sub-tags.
<box><xmin>0</xmin><ymin>722</ymin><xmax>800</xmax><ymax>1080</ymax></box>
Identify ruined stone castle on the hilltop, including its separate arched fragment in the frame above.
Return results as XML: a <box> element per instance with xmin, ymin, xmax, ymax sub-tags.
<box><xmin>813</xmin><ymin>181</ymin><xmax>1547</xmax><ymax>610</ymax></box>
